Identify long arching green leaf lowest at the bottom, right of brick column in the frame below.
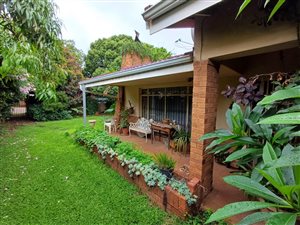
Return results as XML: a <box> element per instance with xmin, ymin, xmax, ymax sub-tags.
<box><xmin>205</xmin><ymin>201</ymin><xmax>277</xmax><ymax>224</ymax></box>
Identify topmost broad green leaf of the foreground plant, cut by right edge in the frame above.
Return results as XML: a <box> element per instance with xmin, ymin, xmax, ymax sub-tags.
<box><xmin>258</xmin><ymin>87</ymin><xmax>300</xmax><ymax>105</ymax></box>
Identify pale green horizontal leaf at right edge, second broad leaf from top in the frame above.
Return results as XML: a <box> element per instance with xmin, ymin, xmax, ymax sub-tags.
<box><xmin>258</xmin><ymin>112</ymin><xmax>300</xmax><ymax>125</ymax></box>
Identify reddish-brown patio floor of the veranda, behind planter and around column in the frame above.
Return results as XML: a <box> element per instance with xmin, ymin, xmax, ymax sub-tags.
<box><xmin>112</xmin><ymin>133</ymin><xmax>247</xmax><ymax>223</ymax></box>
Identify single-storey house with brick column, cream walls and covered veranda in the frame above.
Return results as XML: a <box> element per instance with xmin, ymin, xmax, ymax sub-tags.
<box><xmin>80</xmin><ymin>0</ymin><xmax>300</xmax><ymax>207</ymax></box>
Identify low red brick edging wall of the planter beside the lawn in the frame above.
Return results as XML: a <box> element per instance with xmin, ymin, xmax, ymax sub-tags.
<box><xmin>93</xmin><ymin>146</ymin><xmax>199</xmax><ymax>218</ymax></box>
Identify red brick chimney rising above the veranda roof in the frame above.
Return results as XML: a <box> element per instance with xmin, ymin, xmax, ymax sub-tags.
<box><xmin>121</xmin><ymin>52</ymin><xmax>152</xmax><ymax>70</ymax></box>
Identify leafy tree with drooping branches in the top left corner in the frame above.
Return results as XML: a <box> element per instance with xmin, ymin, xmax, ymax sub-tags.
<box><xmin>0</xmin><ymin>0</ymin><xmax>65</xmax><ymax>98</ymax></box>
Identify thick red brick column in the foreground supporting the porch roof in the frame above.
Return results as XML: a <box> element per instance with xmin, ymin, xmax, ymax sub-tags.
<box><xmin>190</xmin><ymin>60</ymin><xmax>218</xmax><ymax>196</ymax></box>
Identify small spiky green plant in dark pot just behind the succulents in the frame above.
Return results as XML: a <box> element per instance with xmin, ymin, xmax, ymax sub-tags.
<box><xmin>153</xmin><ymin>153</ymin><xmax>176</xmax><ymax>179</ymax></box>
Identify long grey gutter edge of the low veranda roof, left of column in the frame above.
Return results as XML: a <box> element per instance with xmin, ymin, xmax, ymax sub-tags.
<box><xmin>79</xmin><ymin>52</ymin><xmax>193</xmax><ymax>86</ymax></box>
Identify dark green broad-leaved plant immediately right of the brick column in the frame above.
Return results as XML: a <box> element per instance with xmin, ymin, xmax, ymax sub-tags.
<box><xmin>200</xmin><ymin>103</ymin><xmax>296</xmax><ymax>176</ymax></box>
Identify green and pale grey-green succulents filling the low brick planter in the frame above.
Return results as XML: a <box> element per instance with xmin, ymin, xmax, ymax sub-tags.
<box><xmin>74</xmin><ymin>127</ymin><xmax>197</xmax><ymax>205</ymax></box>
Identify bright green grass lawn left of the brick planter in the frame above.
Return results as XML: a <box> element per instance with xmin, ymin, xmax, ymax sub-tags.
<box><xmin>0</xmin><ymin>117</ymin><xmax>178</xmax><ymax>224</ymax></box>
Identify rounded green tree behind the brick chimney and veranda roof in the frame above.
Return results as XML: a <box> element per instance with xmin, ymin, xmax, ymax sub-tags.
<box><xmin>84</xmin><ymin>35</ymin><xmax>171</xmax><ymax>77</ymax></box>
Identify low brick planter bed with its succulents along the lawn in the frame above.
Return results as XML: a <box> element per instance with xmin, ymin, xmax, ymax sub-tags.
<box><xmin>75</xmin><ymin>129</ymin><xmax>198</xmax><ymax>218</ymax></box>
